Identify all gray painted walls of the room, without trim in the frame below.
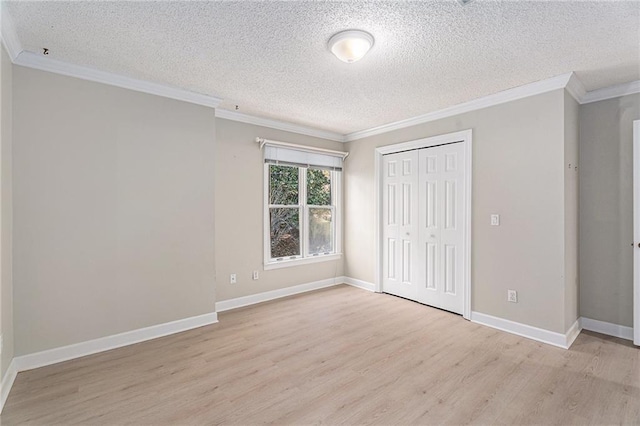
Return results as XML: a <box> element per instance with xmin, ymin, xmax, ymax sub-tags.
<box><xmin>7</xmin><ymin>56</ymin><xmax>640</xmax><ymax>360</ymax></box>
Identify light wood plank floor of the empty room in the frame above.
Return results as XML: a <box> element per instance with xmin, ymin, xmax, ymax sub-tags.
<box><xmin>0</xmin><ymin>286</ymin><xmax>640</xmax><ymax>425</ymax></box>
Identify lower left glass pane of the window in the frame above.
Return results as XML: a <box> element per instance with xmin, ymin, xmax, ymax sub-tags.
<box><xmin>269</xmin><ymin>207</ymin><xmax>300</xmax><ymax>259</ymax></box>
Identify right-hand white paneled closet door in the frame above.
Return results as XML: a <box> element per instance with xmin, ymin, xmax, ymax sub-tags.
<box><xmin>416</xmin><ymin>143</ymin><xmax>466</xmax><ymax>314</ymax></box>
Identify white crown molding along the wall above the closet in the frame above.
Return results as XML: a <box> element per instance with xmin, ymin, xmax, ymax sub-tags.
<box><xmin>345</xmin><ymin>73</ymin><xmax>577</xmax><ymax>142</ymax></box>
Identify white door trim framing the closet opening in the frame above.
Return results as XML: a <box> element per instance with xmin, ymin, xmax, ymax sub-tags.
<box><xmin>374</xmin><ymin>129</ymin><xmax>473</xmax><ymax>320</ymax></box>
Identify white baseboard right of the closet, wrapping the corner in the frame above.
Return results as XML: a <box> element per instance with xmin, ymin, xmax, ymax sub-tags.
<box><xmin>471</xmin><ymin>312</ymin><xmax>580</xmax><ymax>349</ymax></box>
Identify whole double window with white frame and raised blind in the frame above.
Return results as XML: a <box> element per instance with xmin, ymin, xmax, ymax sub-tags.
<box><xmin>264</xmin><ymin>146</ymin><xmax>342</xmax><ymax>269</ymax></box>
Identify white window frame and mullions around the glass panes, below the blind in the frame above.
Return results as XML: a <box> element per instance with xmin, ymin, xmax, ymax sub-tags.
<box><xmin>262</xmin><ymin>163</ymin><xmax>342</xmax><ymax>270</ymax></box>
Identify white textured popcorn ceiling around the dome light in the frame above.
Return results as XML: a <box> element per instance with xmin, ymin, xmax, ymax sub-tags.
<box><xmin>6</xmin><ymin>0</ymin><xmax>640</xmax><ymax>133</ymax></box>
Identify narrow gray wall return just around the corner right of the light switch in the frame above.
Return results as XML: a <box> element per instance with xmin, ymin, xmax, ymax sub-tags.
<box><xmin>564</xmin><ymin>92</ymin><xmax>580</xmax><ymax>330</ymax></box>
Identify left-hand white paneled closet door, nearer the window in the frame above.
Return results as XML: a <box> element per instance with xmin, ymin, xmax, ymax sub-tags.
<box><xmin>382</xmin><ymin>151</ymin><xmax>420</xmax><ymax>300</ymax></box>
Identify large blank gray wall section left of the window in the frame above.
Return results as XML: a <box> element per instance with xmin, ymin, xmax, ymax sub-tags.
<box><xmin>13</xmin><ymin>67</ymin><xmax>216</xmax><ymax>355</ymax></box>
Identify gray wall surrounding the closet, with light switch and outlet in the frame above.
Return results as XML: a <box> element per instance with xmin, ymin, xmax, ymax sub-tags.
<box><xmin>345</xmin><ymin>90</ymin><xmax>567</xmax><ymax>333</ymax></box>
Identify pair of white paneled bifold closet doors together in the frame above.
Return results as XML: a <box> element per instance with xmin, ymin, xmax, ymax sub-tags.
<box><xmin>382</xmin><ymin>143</ymin><xmax>466</xmax><ymax>314</ymax></box>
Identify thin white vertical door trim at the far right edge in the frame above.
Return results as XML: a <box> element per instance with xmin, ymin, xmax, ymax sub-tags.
<box><xmin>633</xmin><ymin>120</ymin><xmax>640</xmax><ymax>346</ymax></box>
